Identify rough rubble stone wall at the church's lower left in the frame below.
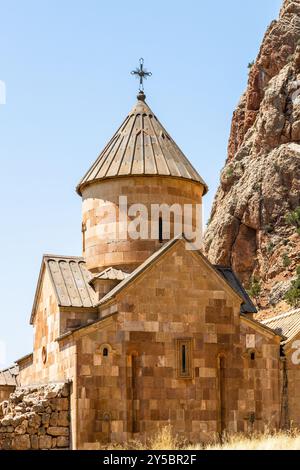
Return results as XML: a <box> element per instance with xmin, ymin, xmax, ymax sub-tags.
<box><xmin>0</xmin><ymin>384</ymin><xmax>70</xmax><ymax>450</ymax></box>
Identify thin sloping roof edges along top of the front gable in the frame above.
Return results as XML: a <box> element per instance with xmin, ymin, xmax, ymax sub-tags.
<box><xmin>98</xmin><ymin>235</ymin><xmax>256</xmax><ymax>313</ymax></box>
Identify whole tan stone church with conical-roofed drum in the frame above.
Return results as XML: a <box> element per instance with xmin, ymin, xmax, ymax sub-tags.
<box><xmin>0</xmin><ymin>92</ymin><xmax>300</xmax><ymax>449</ymax></box>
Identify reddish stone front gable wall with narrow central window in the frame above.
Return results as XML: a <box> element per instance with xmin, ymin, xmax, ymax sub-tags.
<box><xmin>77</xmin><ymin>242</ymin><xmax>280</xmax><ymax>446</ymax></box>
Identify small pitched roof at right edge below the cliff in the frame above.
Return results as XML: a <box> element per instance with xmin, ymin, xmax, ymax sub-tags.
<box><xmin>261</xmin><ymin>308</ymin><xmax>300</xmax><ymax>342</ymax></box>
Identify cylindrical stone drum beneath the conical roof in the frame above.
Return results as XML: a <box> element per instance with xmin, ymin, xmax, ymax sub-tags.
<box><xmin>82</xmin><ymin>176</ymin><xmax>203</xmax><ymax>272</ymax></box>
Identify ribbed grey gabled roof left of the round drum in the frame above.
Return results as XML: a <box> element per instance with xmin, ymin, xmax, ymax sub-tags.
<box><xmin>30</xmin><ymin>255</ymin><xmax>97</xmax><ymax>323</ymax></box>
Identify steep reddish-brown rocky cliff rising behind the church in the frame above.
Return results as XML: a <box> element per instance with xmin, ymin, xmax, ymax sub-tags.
<box><xmin>205</xmin><ymin>0</ymin><xmax>300</xmax><ymax>312</ymax></box>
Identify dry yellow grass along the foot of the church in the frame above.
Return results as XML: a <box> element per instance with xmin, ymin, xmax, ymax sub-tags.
<box><xmin>102</xmin><ymin>426</ymin><xmax>300</xmax><ymax>450</ymax></box>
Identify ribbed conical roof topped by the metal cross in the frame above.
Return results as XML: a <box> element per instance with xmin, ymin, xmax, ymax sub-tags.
<box><xmin>77</xmin><ymin>93</ymin><xmax>208</xmax><ymax>195</ymax></box>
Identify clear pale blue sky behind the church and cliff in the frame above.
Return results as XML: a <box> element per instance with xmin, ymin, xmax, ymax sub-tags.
<box><xmin>0</xmin><ymin>0</ymin><xmax>281</xmax><ymax>366</ymax></box>
